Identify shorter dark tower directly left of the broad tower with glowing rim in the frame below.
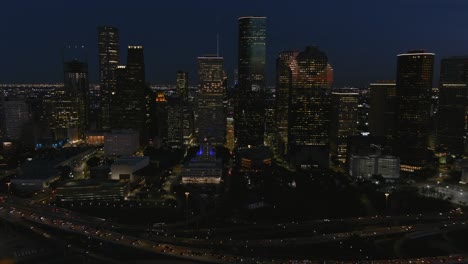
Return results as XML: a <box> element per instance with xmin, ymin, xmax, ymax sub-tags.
<box><xmin>369</xmin><ymin>81</ymin><xmax>397</xmax><ymax>140</ymax></box>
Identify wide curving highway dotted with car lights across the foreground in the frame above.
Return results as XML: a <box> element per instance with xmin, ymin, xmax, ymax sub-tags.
<box><xmin>0</xmin><ymin>197</ymin><xmax>467</xmax><ymax>263</ymax></box>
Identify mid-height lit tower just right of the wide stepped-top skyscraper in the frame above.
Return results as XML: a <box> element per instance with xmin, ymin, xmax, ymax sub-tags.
<box><xmin>330</xmin><ymin>90</ymin><xmax>359</xmax><ymax>165</ymax></box>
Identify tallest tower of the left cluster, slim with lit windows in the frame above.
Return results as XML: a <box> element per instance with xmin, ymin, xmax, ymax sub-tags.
<box><xmin>97</xmin><ymin>26</ymin><xmax>119</xmax><ymax>130</ymax></box>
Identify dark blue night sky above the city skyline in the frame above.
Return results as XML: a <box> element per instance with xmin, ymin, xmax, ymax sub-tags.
<box><xmin>0</xmin><ymin>0</ymin><xmax>468</xmax><ymax>87</ymax></box>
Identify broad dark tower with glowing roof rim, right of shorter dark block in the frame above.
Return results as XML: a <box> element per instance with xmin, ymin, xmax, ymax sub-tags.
<box><xmin>395</xmin><ymin>50</ymin><xmax>434</xmax><ymax>172</ymax></box>
